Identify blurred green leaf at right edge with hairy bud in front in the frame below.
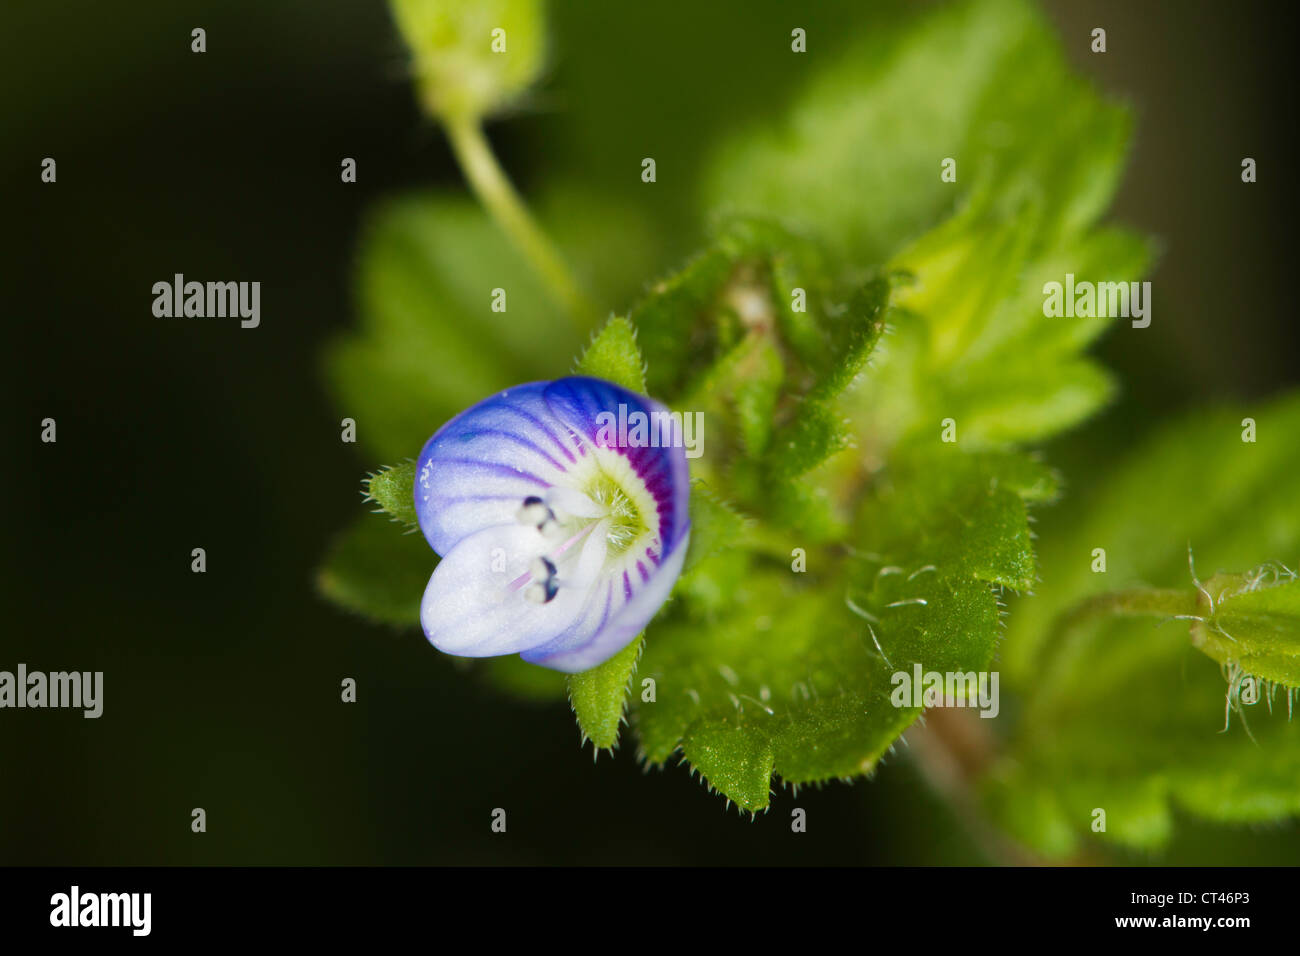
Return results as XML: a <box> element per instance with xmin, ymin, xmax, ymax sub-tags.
<box><xmin>988</xmin><ymin>397</ymin><xmax>1300</xmax><ymax>856</ymax></box>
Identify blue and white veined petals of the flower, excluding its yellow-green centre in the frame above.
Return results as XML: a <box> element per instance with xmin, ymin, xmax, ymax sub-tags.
<box><xmin>415</xmin><ymin>376</ymin><xmax>690</xmax><ymax>672</ymax></box>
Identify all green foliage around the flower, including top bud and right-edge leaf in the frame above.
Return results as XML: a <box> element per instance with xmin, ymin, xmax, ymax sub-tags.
<box><xmin>312</xmin><ymin>0</ymin><xmax>1300</xmax><ymax>855</ymax></box>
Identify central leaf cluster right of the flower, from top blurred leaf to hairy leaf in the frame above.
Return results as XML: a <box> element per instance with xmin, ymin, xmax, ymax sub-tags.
<box><xmin>605</xmin><ymin>3</ymin><xmax>1148</xmax><ymax>809</ymax></box>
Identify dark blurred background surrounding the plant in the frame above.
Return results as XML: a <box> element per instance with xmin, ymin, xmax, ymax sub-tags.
<box><xmin>0</xmin><ymin>0</ymin><xmax>1297</xmax><ymax>864</ymax></box>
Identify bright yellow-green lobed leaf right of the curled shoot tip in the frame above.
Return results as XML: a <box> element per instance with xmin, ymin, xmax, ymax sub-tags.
<box><xmin>848</xmin><ymin>199</ymin><xmax>1151</xmax><ymax>447</ymax></box>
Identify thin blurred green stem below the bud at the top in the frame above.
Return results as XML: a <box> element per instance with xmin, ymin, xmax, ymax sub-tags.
<box><xmin>443</xmin><ymin>116</ymin><xmax>595</xmax><ymax>333</ymax></box>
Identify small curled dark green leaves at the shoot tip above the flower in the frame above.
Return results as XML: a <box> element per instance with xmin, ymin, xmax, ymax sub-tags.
<box><xmin>621</xmin><ymin>217</ymin><xmax>892</xmax><ymax>540</ymax></box>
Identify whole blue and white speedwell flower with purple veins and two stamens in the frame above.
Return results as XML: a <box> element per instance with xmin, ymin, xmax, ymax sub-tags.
<box><xmin>415</xmin><ymin>377</ymin><xmax>690</xmax><ymax>674</ymax></box>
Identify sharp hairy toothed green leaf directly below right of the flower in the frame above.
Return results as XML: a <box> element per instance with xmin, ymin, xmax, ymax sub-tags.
<box><xmin>633</xmin><ymin>449</ymin><xmax>1054</xmax><ymax>810</ymax></box>
